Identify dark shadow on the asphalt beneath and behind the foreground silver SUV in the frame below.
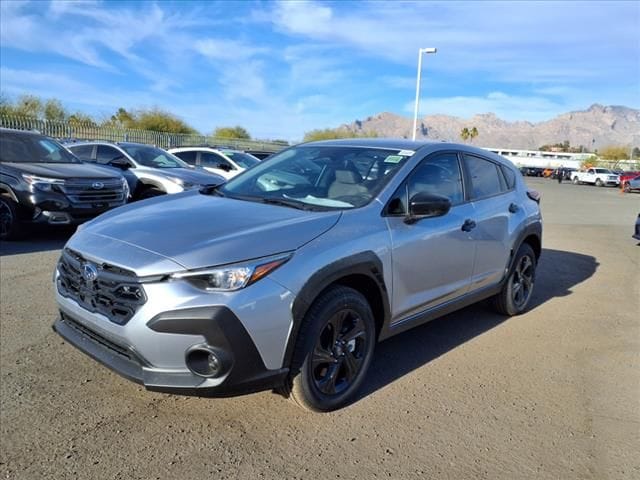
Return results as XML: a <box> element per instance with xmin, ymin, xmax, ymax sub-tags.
<box><xmin>356</xmin><ymin>249</ymin><xmax>599</xmax><ymax>401</ymax></box>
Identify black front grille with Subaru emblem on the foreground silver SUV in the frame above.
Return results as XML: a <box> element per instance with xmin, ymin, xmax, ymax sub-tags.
<box><xmin>57</xmin><ymin>248</ymin><xmax>147</xmax><ymax>325</ymax></box>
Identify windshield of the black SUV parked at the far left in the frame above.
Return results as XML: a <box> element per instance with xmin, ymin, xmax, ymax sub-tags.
<box><xmin>0</xmin><ymin>132</ymin><xmax>81</xmax><ymax>163</ymax></box>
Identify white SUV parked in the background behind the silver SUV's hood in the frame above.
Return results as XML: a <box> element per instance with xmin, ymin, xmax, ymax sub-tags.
<box><xmin>169</xmin><ymin>147</ymin><xmax>260</xmax><ymax>180</ymax></box>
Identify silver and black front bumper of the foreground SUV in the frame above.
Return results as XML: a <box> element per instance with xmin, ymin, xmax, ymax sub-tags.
<box><xmin>53</xmin><ymin>266</ymin><xmax>293</xmax><ymax>396</ymax></box>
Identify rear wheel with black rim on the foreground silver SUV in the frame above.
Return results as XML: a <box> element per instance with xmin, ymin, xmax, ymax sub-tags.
<box><xmin>493</xmin><ymin>243</ymin><xmax>536</xmax><ymax>317</ymax></box>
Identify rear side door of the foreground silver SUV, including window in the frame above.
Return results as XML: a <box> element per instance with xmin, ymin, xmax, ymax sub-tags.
<box><xmin>462</xmin><ymin>153</ymin><xmax>525</xmax><ymax>291</ymax></box>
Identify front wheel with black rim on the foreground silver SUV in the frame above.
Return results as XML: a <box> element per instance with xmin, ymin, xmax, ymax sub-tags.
<box><xmin>283</xmin><ymin>285</ymin><xmax>376</xmax><ymax>412</ymax></box>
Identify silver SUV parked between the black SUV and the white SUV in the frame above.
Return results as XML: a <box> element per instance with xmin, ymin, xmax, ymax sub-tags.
<box><xmin>65</xmin><ymin>141</ymin><xmax>225</xmax><ymax>200</ymax></box>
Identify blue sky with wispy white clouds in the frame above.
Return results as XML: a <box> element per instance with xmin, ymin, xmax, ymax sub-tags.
<box><xmin>0</xmin><ymin>1</ymin><xmax>640</xmax><ymax>140</ymax></box>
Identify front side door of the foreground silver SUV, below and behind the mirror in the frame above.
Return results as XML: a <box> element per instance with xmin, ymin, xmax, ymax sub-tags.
<box><xmin>385</xmin><ymin>152</ymin><xmax>475</xmax><ymax>323</ymax></box>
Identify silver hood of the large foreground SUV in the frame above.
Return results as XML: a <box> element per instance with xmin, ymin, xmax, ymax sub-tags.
<box><xmin>70</xmin><ymin>192</ymin><xmax>341</xmax><ymax>273</ymax></box>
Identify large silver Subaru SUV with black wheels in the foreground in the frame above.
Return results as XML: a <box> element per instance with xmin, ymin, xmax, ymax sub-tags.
<box><xmin>54</xmin><ymin>139</ymin><xmax>542</xmax><ymax>411</ymax></box>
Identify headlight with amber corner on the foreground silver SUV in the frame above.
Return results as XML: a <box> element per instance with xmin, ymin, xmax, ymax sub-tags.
<box><xmin>171</xmin><ymin>252</ymin><xmax>293</xmax><ymax>292</ymax></box>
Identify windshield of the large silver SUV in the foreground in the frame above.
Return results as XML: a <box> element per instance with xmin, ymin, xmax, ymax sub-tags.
<box><xmin>219</xmin><ymin>145</ymin><xmax>413</xmax><ymax>210</ymax></box>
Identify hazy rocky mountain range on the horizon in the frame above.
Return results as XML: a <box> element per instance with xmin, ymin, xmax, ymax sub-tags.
<box><xmin>338</xmin><ymin>104</ymin><xmax>640</xmax><ymax>150</ymax></box>
